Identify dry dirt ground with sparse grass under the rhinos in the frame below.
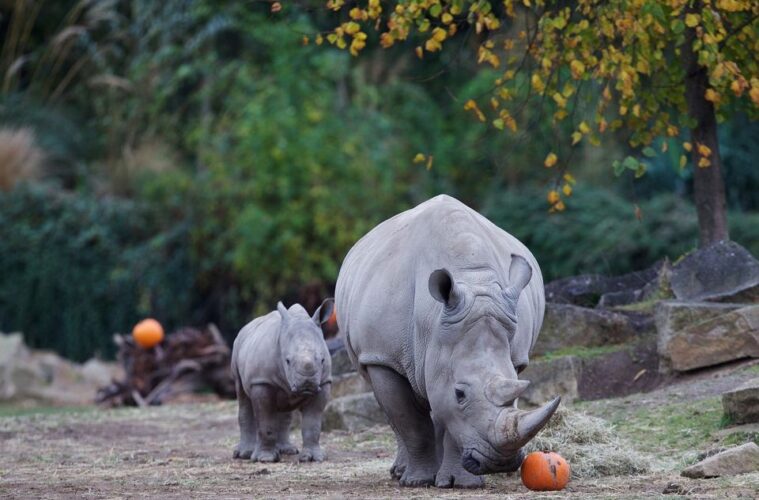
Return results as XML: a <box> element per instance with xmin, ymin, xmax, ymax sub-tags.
<box><xmin>0</xmin><ymin>366</ymin><xmax>759</xmax><ymax>498</ymax></box>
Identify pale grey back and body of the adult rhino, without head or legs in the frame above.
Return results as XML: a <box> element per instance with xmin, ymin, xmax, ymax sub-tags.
<box><xmin>335</xmin><ymin>195</ymin><xmax>545</xmax><ymax>393</ymax></box>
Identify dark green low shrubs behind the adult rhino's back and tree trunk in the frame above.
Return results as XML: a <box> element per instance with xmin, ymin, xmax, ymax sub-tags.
<box><xmin>483</xmin><ymin>186</ymin><xmax>759</xmax><ymax>280</ymax></box>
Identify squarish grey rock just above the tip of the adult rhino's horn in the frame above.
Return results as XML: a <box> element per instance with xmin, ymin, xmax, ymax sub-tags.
<box><xmin>519</xmin><ymin>356</ymin><xmax>582</xmax><ymax>407</ymax></box>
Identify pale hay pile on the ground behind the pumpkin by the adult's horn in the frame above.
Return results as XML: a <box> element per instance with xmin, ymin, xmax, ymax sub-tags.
<box><xmin>525</xmin><ymin>406</ymin><xmax>652</xmax><ymax>478</ymax></box>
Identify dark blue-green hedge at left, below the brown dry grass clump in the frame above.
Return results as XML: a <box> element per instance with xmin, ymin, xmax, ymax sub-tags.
<box><xmin>0</xmin><ymin>187</ymin><xmax>192</xmax><ymax>361</ymax></box>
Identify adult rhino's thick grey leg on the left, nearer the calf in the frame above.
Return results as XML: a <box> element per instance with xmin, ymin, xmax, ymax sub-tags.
<box><xmin>367</xmin><ymin>365</ymin><xmax>438</xmax><ymax>486</ymax></box>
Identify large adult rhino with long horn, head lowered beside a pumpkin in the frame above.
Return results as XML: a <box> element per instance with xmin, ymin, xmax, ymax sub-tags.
<box><xmin>336</xmin><ymin>195</ymin><xmax>559</xmax><ymax>487</ymax></box>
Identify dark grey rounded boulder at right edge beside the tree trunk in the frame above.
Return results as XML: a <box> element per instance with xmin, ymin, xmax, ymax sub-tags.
<box><xmin>670</xmin><ymin>241</ymin><xmax>759</xmax><ymax>303</ymax></box>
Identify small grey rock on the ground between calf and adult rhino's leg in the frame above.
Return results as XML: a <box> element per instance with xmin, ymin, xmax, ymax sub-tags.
<box><xmin>322</xmin><ymin>392</ymin><xmax>387</xmax><ymax>432</ymax></box>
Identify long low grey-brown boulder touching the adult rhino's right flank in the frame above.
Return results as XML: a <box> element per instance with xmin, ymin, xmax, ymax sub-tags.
<box><xmin>533</xmin><ymin>303</ymin><xmax>640</xmax><ymax>356</ymax></box>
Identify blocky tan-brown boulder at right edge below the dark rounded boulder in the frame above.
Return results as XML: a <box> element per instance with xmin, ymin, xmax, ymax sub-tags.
<box><xmin>656</xmin><ymin>301</ymin><xmax>759</xmax><ymax>371</ymax></box>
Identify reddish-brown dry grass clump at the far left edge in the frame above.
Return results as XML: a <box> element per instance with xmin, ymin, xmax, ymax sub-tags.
<box><xmin>0</xmin><ymin>128</ymin><xmax>45</xmax><ymax>191</ymax></box>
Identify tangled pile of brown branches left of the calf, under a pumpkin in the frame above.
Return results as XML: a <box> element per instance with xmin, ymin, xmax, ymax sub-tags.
<box><xmin>95</xmin><ymin>324</ymin><xmax>235</xmax><ymax>406</ymax></box>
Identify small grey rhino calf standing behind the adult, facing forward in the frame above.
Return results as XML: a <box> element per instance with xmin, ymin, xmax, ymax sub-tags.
<box><xmin>232</xmin><ymin>299</ymin><xmax>334</xmax><ymax>462</ymax></box>
